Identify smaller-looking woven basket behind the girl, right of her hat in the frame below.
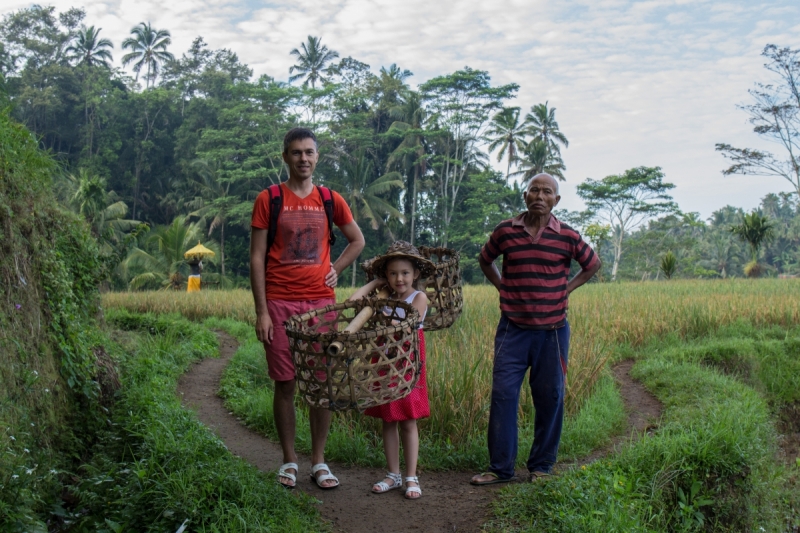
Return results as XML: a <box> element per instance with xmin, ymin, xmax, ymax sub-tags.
<box><xmin>361</xmin><ymin>246</ymin><xmax>464</xmax><ymax>331</ymax></box>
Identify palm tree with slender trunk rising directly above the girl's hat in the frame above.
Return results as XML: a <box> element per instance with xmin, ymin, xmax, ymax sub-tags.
<box><xmin>386</xmin><ymin>91</ymin><xmax>428</xmax><ymax>244</ymax></box>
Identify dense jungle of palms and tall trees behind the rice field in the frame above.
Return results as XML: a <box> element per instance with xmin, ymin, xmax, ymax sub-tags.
<box><xmin>0</xmin><ymin>6</ymin><xmax>800</xmax><ymax>289</ymax></box>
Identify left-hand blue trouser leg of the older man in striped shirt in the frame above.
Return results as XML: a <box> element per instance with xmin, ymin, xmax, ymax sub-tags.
<box><xmin>478</xmin><ymin>316</ymin><xmax>530</xmax><ymax>479</ymax></box>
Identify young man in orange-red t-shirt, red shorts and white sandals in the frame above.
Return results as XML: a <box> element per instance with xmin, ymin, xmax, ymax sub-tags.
<box><xmin>250</xmin><ymin>128</ymin><xmax>364</xmax><ymax>489</ymax></box>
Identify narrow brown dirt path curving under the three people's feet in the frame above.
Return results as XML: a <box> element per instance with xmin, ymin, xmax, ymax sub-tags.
<box><xmin>178</xmin><ymin>333</ymin><xmax>660</xmax><ymax>533</ymax></box>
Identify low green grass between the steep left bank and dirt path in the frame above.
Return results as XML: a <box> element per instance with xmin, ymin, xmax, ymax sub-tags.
<box><xmin>61</xmin><ymin>311</ymin><xmax>325</xmax><ymax>532</ymax></box>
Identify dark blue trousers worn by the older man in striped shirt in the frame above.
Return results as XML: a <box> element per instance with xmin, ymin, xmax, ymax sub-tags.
<box><xmin>489</xmin><ymin>315</ymin><xmax>569</xmax><ymax>479</ymax></box>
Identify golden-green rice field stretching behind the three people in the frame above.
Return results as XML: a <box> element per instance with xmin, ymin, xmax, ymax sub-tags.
<box><xmin>102</xmin><ymin>279</ymin><xmax>800</xmax><ymax>432</ymax></box>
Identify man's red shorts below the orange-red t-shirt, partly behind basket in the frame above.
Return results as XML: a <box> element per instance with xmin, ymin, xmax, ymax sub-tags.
<box><xmin>264</xmin><ymin>298</ymin><xmax>336</xmax><ymax>381</ymax></box>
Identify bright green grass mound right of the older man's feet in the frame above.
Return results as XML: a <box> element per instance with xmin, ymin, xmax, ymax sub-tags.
<box><xmin>490</xmin><ymin>322</ymin><xmax>800</xmax><ymax>532</ymax></box>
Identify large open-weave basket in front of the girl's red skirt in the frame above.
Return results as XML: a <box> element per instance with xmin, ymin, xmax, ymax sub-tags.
<box><xmin>286</xmin><ymin>299</ymin><xmax>420</xmax><ymax>411</ymax></box>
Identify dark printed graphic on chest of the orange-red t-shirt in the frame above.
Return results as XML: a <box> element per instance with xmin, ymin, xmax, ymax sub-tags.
<box><xmin>280</xmin><ymin>209</ymin><xmax>326</xmax><ymax>265</ymax></box>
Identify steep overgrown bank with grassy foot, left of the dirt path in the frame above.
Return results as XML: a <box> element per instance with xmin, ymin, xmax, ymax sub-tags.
<box><xmin>0</xmin><ymin>106</ymin><xmax>324</xmax><ymax>533</ymax></box>
